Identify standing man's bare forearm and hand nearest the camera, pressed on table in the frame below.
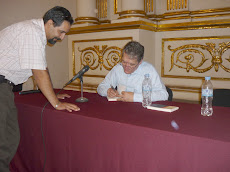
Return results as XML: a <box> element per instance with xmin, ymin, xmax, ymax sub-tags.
<box><xmin>32</xmin><ymin>69</ymin><xmax>80</xmax><ymax>112</ymax></box>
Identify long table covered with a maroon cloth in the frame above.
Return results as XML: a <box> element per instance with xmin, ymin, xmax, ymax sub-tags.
<box><xmin>10</xmin><ymin>90</ymin><xmax>230</xmax><ymax>172</ymax></box>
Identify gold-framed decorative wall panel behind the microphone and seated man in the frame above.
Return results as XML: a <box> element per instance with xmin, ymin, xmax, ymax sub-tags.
<box><xmin>68</xmin><ymin>37</ymin><xmax>133</xmax><ymax>92</ymax></box>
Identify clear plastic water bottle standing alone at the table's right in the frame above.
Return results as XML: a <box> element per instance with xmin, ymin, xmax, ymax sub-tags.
<box><xmin>201</xmin><ymin>76</ymin><xmax>213</xmax><ymax>116</ymax></box>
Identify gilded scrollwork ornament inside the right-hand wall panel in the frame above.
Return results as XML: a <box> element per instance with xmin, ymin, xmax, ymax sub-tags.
<box><xmin>168</xmin><ymin>42</ymin><xmax>230</xmax><ymax>73</ymax></box>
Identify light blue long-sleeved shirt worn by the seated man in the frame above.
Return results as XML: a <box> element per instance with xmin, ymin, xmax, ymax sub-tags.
<box><xmin>97</xmin><ymin>61</ymin><xmax>168</xmax><ymax>102</ymax></box>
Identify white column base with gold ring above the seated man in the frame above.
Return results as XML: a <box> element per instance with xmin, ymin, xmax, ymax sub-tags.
<box><xmin>119</xmin><ymin>0</ymin><xmax>146</xmax><ymax>19</ymax></box>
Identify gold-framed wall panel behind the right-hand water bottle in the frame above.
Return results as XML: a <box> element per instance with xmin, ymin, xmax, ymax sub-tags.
<box><xmin>162</xmin><ymin>36</ymin><xmax>230</xmax><ymax>80</ymax></box>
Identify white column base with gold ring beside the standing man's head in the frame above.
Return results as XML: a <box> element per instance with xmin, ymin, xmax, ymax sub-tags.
<box><xmin>75</xmin><ymin>0</ymin><xmax>99</xmax><ymax>24</ymax></box>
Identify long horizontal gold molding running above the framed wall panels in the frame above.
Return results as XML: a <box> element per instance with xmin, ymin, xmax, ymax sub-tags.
<box><xmin>67</xmin><ymin>19</ymin><xmax>230</xmax><ymax>35</ymax></box>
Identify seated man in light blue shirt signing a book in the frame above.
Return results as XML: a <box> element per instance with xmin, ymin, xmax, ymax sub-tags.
<box><xmin>97</xmin><ymin>41</ymin><xmax>168</xmax><ymax>102</ymax></box>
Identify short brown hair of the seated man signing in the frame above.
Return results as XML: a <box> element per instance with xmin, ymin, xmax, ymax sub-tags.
<box><xmin>122</xmin><ymin>41</ymin><xmax>144</xmax><ymax>62</ymax></box>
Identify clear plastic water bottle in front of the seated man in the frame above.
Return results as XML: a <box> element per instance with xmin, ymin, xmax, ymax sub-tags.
<box><xmin>142</xmin><ymin>74</ymin><xmax>152</xmax><ymax>107</ymax></box>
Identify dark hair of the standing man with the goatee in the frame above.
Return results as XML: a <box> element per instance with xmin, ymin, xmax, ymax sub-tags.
<box><xmin>43</xmin><ymin>6</ymin><xmax>73</xmax><ymax>27</ymax></box>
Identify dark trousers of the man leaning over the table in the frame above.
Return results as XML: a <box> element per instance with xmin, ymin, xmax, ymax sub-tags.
<box><xmin>0</xmin><ymin>83</ymin><xmax>20</xmax><ymax>172</ymax></box>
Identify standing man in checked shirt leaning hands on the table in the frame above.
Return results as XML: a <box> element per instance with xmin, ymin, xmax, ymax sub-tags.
<box><xmin>0</xmin><ymin>6</ymin><xmax>80</xmax><ymax>172</ymax></box>
